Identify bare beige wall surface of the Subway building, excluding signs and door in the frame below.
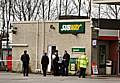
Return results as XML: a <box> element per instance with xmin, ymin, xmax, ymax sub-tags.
<box><xmin>12</xmin><ymin>20</ymin><xmax>91</xmax><ymax>74</ymax></box>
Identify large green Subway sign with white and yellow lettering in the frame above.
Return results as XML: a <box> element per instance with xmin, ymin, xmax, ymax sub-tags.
<box><xmin>59</xmin><ymin>22</ymin><xmax>85</xmax><ymax>33</ymax></box>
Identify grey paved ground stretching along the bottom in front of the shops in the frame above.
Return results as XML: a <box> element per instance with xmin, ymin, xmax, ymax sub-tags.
<box><xmin>0</xmin><ymin>72</ymin><xmax>120</xmax><ymax>83</ymax></box>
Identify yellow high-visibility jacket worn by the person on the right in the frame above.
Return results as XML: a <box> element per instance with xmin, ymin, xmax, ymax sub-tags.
<box><xmin>78</xmin><ymin>55</ymin><xmax>88</xmax><ymax>68</ymax></box>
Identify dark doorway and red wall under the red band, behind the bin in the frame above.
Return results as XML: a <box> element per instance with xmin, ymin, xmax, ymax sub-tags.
<box><xmin>98</xmin><ymin>39</ymin><xmax>118</xmax><ymax>75</ymax></box>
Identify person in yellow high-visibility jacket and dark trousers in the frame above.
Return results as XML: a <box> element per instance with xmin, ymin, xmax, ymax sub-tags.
<box><xmin>78</xmin><ymin>53</ymin><xmax>88</xmax><ymax>78</ymax></box>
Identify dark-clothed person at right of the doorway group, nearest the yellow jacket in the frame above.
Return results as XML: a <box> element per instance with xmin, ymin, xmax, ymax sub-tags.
<box><xmin>63</xmin><ymin>50</ymin><xmax>70</xmax><ymax>76</ymax></box>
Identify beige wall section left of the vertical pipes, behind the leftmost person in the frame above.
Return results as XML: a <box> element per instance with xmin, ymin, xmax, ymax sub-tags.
<box><xmin>12</xmin><ymin>22</ymin><xmax>37</xmax><ymax>71</ymax></box>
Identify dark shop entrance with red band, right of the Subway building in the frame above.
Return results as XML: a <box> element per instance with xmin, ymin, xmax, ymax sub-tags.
<box><xmin>92</xmin><ymin>29</ymin><xmax>119</xmax><ymax>75</ymax></box>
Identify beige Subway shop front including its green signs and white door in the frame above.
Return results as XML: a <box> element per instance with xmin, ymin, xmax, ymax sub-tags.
<box><xmin>12</xmin><ymin>19</ymin><xmax>92</xmax><ymax>74</ymax></box>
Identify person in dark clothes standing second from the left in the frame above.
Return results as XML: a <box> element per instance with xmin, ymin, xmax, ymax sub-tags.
<box><xmin>41</xmin><ymin>53</ymin><xmax>49</xmax><ymax>76</ymax></box>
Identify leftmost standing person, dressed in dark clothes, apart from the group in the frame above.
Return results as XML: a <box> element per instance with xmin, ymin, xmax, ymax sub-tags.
<box><xmin>21</xmin><ymin>50</ymin><xmax>30</xmax><ymax>76</ymax></box>
